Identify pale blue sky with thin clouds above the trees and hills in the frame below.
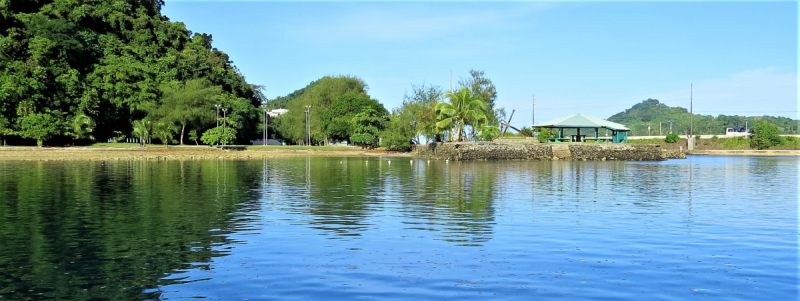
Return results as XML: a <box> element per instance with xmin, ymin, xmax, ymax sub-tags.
<box><xmin>162</xmin><ymin>0</ymin><xmax>798</xmax><ymax>126</ymax></box>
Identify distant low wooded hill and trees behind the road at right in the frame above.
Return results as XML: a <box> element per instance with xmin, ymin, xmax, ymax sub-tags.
<box><xmin>608</xmin><ymin>99</ymin><xmax>800</xmax><ymax>136</ymax></box>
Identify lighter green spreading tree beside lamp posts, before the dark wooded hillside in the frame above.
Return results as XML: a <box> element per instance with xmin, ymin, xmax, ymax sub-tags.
<box><xmin>153</xmin><ymin>79</ymin><xmax>222</xmax><ymax>145</ymax></box>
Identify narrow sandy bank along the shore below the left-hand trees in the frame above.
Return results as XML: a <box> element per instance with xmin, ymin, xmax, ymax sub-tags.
<box><xmin>0</xmin><ymin>147</ymin><xmax>411</xmax><ymax>161</ymax></box>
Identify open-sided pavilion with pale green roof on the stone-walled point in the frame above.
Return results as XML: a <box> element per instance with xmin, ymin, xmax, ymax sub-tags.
<box><xmin>533</xmin><ymin>114</ymin><xmax>631</xmax><ymax>143</ymax></box>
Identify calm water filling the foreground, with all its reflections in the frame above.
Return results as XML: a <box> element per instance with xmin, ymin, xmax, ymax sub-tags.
<box><xmin>0</xmin><ymin>157</ymin><xmax>800</xmax><ymax>300</ymax></box>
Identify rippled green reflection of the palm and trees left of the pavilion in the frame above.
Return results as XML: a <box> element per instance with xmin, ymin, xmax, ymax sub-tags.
<box><xmin>400</xmin><ymin>160</ymin><xmax>498</xmax><ymax>245</ymax></box>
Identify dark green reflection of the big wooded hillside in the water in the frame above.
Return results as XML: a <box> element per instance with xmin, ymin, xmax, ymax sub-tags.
<box><xmin>0</xmin><ymin>161</ymin><xmax>258</xmax><ymax>300</ymax></box>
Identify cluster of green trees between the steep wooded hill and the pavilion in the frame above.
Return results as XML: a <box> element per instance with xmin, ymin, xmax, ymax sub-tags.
<box><xmin>265</xmin><ymin>70</ymin><xmax>505</xmax><ymax>150</ymax></box>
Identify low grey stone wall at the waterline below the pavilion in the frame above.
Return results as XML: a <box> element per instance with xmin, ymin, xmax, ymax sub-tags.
<box><xmin>413</xmin><ymin>142</ymin><xmax>667</xmax><ymax>161</ymax></box>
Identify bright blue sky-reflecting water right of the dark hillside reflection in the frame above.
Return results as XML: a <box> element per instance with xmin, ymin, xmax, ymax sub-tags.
<box><xmin>163</xmin><ymin>156</ymin><xmax>798</xmax><ymax>300</ymax></box>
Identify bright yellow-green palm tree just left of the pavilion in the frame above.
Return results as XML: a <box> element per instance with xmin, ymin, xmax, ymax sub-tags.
<box><xmin>435</xmin><ymin>88</ymin><xmax>487</xmax><ymax>141</ymax></box>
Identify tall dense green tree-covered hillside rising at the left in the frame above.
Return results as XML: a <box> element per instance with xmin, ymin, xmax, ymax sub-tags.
<box><xmin>0</xmin><ymin>0</ymin><xmax>264</xmax><ymax>145</ymax></box>
